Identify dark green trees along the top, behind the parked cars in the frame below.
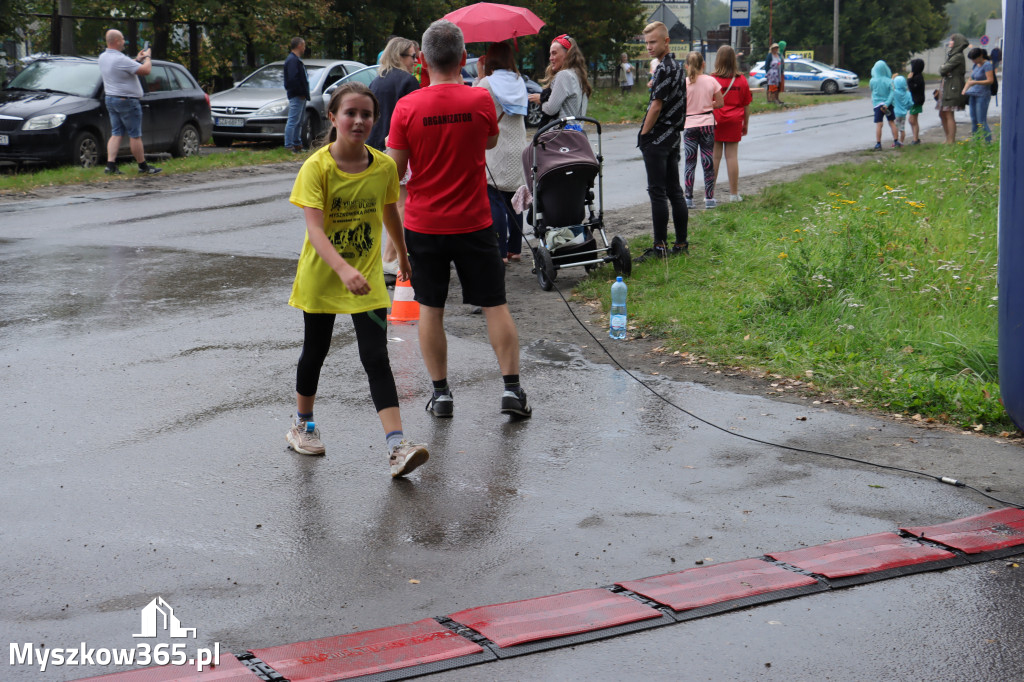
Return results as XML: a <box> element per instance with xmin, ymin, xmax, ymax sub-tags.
<box><xmin>6</xmin><ymin>0</ymin><xmax>645</xmax><ymax>86</ymax></box>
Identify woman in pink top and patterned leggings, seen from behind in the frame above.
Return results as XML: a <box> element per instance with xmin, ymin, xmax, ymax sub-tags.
<box><xmin>683</xmin><ymin>52</ymin><xmax>725</xmax><ymax>208</ymax></box>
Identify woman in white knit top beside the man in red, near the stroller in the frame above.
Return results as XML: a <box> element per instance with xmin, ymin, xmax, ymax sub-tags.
<box><xmin>477</xmin><ymin>43</ymin><xmax>527</xmax><ymax>263</ymax></box>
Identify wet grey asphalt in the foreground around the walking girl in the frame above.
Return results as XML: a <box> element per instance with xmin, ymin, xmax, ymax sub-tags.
<box><xmin>0</xmin><ymin>98</ymin><xmax>1024</xmax><ymax>681</ymax></box>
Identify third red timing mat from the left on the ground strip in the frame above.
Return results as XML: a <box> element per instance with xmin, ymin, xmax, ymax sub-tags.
<box><xmin>449</xmin><ymin>588</ymin><xmax>662</xmax><ymax>647</ymax></box>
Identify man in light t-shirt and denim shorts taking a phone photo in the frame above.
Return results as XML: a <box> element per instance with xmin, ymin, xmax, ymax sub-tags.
<box><xmin>99</xmin><ymin>29</ymin><xmax>163</xmax><ymax>175</ymax></box>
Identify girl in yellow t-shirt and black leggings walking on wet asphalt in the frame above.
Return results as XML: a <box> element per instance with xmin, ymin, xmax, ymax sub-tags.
<box><xmin>286</xmin><ymin>83</ymin><xmax>429</xmax><ymax>476</ymax></box>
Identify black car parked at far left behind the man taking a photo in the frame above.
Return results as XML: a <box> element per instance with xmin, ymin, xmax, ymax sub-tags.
<box><xmin>0</xmin><ymin>56</ymin><xmax>213</xmax><ymax>167</ymax></box>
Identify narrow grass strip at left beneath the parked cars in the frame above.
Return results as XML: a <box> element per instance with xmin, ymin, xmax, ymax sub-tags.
<box><xmin>0</xmin><ymin>146</ymin><xmax>305</xmax><ymax>196</ymax></box>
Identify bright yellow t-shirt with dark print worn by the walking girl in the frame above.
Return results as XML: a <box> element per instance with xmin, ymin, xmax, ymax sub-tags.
<box><xmin>288</xmin><ymin>146</ymin><xmax>398</xmax><ymax>314</ymax></box>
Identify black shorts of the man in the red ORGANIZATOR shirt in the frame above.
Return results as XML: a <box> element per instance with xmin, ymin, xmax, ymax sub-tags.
<box><xmin>406</xmin><ymin>225</ymin><xmax>508</xmax><ymax>308</ymax></box>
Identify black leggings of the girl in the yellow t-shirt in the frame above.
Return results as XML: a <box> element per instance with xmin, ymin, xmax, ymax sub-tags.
<box><xmin>295</xmin><ymin>308</ymin><xmax>398</xmax><ymax>412</ymax></box>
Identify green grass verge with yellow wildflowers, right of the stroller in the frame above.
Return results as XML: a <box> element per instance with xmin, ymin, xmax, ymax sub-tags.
<box><xmin>578</xmin><ymin>142</ymin><xmax>1015</xmax><ymax>432</ymax></box>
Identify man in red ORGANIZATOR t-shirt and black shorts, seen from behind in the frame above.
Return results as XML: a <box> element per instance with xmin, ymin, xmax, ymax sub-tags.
<box><xmin>386</xmin><ymin>19</ymin><xmax>532</xmax><ymax>419</ymax></box>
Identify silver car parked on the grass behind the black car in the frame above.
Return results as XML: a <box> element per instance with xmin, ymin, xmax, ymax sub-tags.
<box><xmin>210</xmin><ymin>59</ymin><xmax>366</xmax><ymax>146</ymax></box>
